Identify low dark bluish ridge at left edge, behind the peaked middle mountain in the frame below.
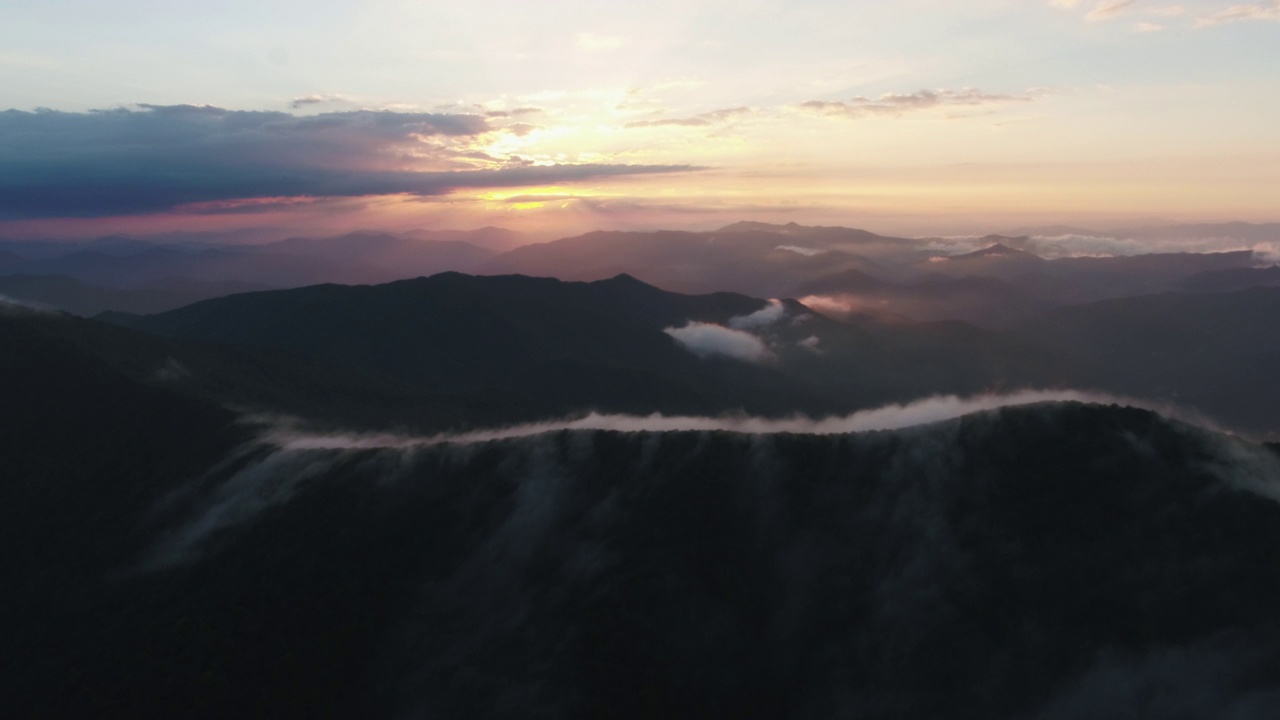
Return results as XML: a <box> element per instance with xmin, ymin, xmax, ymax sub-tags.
<box><xmin>0</xmin><ymin>274</ymin><xmax>266</xmax><ymax>316</ymax></box>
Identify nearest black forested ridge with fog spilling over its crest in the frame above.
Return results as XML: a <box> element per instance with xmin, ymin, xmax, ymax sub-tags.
<box><xmin>0</xmin><ymin>394</ymin><xmax>1280</xmax><ymax>720</ymax></box>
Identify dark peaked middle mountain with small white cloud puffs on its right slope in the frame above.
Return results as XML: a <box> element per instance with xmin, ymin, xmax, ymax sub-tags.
<box><xmin>97</xmin><ymin>273</ymin><xmax>1064</xmax><ymax>414</ymax></box>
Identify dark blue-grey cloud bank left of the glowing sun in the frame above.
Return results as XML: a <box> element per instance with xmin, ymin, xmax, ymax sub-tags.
<box><xmin>0</xmin><ymin>105</ymin><xmax>694</xmax><ymax>219</ymax></box>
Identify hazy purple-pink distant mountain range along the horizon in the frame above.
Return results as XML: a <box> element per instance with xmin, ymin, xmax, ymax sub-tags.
<box><xmin>0</xmin><ymin>222</ymin><xmax>1268</xmax><ymax>328</ymax></box>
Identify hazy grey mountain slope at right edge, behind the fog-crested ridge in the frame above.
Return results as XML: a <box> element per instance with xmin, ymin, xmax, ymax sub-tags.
<box><xmin>1023</xmin><ymin>287</ymin><xmax>1280</xmax><ymax>432</ymax></box>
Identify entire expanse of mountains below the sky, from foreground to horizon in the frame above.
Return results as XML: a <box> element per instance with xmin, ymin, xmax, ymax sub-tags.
<box><xmin>0</xmin><ymin>223</ymin><xmax>1280</xmax><ymax>720</ymax></box>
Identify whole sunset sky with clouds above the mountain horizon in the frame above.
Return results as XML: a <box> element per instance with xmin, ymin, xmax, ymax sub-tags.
<box><xmin>0</xmin><ymin>0</ymin><xmax>1280</xmax><ymax>237</ymax></box>
